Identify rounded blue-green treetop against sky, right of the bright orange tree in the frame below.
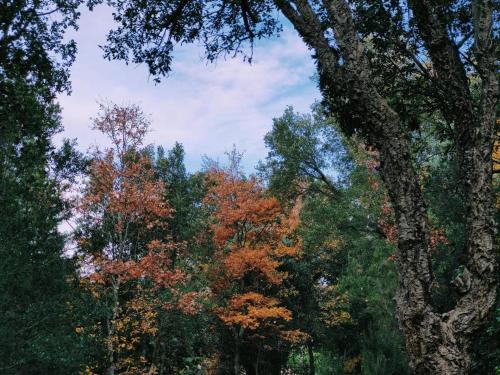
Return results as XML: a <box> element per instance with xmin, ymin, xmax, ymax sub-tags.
<box><xmin>259</xmin><ymin>104</ymin><xmax>350</xmax><ymax>197</ymax></box>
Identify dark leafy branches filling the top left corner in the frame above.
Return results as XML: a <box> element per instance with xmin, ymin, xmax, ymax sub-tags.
<box><xmin>0</xmin><ymin>0</ymin><xmax>82</xmax><ymax>98</ymax></box>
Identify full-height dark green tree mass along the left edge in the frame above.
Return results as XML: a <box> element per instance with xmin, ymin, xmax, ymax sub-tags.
<box><xmin>0</xmin><ymin>1</ymin><xmax>87</xmax><ymax>374</ymax></box>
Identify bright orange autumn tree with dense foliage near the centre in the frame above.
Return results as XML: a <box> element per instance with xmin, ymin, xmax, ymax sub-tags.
<box><xmin>205</xmin><ymin>151</ymin><xmax>302</xmax><ymax>374</ymax></box>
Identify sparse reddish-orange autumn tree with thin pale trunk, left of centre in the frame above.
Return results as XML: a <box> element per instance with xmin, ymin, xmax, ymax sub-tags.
<box><xmin>76</xmin><ymin>104</ymin><xmax>188</xmax><ymax>374</ymax></box>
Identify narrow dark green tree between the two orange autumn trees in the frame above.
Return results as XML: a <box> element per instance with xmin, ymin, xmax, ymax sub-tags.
<box><xmin>151</xmin><ymin>143</ymin><xmax>218</xmax><ymax>374</ymax></box>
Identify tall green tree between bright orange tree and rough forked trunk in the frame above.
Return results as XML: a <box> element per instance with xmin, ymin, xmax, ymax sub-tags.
<box><xmin>260</xmin><ymin>104</ymin><xmax>408</xmax><ymax>374</ymax></box>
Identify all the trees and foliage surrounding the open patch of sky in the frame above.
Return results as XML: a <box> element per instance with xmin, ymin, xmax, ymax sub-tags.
<box><xmin>0</xmin><ymin>0</ymin><xmax>500</xmax><ymax>375</ymax></box>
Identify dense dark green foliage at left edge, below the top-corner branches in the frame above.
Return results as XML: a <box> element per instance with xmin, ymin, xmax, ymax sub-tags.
<box><xmin>0</xmin><ymin>75</ymin><xmax>84</xmax><ymax>374</ymax></box>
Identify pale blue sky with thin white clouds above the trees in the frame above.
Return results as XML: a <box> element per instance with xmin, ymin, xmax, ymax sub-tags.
<box><xmin>58</xmin><ymin>7</ymin><xmax>320</xmax><ymax>172</ymax></box>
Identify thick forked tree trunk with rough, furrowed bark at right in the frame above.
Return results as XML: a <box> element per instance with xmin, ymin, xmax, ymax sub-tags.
<box><xmin>275</xmin><ymin>0</ymin><xmax>498</xmax><ymax>375</ymax></box>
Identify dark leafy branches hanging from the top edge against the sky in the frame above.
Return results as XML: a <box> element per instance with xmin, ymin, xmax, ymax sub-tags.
<box><xmin>88</xmin><ymin>0</ymin><xmax>280</xmax><ymax>80</ymax></box>
